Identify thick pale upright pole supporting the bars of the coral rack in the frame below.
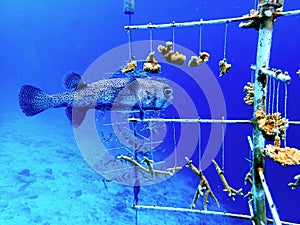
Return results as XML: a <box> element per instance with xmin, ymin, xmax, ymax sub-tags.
<box><xmin>252</xmin><ymin>0</ymin><xmax>274</xmax><ymax>225</ymax></box>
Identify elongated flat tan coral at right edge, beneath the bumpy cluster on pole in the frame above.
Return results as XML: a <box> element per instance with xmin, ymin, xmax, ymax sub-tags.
<box><xmin>262</xmin><ymin>145</ymin><xmax>300</xmax><ymax>166</ymax></box>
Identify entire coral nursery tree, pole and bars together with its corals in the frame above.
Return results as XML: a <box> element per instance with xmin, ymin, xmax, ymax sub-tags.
<box><xmin>125</xmin><ymin>0</ymin><xmax>300</xmax><ymax>225</ymax></box>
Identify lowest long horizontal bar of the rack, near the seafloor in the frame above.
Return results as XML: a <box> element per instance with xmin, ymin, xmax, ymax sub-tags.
<box><xmin>132</xmin><ymin>205</ymin><xmax>300</xmax><ymax>225</ymax></box>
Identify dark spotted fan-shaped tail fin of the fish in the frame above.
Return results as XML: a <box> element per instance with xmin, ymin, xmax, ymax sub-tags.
<box><xmin>19</xmin><ymin>85</ymin><xmax>54</xmax><ymax>116</ymax></box>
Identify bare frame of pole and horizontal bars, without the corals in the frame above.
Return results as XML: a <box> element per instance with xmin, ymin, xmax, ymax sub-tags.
<box><xmin>124</xmin><ymin>0</ymin><xmax>300</xmax><ymax>225</ymax></box>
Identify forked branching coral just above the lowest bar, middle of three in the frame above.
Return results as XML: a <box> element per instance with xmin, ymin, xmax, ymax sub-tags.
<box><xmin>185</xmin><ymin>157</ymin><xmax>220</xmax><ymax>210</ymax></box>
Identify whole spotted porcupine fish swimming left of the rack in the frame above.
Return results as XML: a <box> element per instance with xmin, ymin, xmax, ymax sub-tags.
<box><xmin>19</xmin><ymin>72</ymin><xmax>173</xmax><ymax>127</ymax></box>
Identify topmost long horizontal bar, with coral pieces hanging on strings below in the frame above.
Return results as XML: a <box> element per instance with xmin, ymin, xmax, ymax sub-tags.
<box><xmin>124</xmin><ymin>10</ymin><xmax>300</xmax><ymax>30</ymax></box>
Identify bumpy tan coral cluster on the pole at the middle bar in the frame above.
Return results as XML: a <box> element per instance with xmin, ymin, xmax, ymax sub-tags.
<box><xmin>255</xmin><ymin>109</ymin><xmax>288</xmax><ymax>141</ymax></box>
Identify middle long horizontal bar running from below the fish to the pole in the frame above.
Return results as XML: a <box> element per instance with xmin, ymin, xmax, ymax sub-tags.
<box><xmin>128</xmin><ymin>118</ymin><xmax>252</xmax><ymax>124</ymax></box>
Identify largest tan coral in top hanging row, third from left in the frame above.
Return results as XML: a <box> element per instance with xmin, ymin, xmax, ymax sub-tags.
<box><xmin>158</xmin><ymin>41</ymin><xmax>186</xmax><ymax>65</ymax></box>
